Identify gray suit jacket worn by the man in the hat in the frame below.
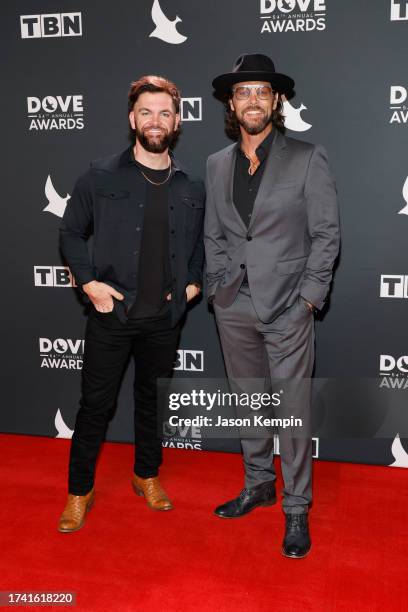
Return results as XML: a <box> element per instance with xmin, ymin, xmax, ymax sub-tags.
<box><xmin>204</xmin><ymin>131</ymin><xmax>340</xmax><ymax>322</ymax></box>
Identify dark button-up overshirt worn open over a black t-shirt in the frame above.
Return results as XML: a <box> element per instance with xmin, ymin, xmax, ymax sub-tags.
<box><xmin>60</xmin><ymin>147</ymin><xmax>205</xmax><ymax>324</ymax></box>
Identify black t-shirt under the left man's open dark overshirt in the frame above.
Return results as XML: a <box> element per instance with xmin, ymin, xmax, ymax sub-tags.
<box><xmin>128</xmin><ymin>162</ymin><xmax>171</xmax><ymax>319</ymax></box>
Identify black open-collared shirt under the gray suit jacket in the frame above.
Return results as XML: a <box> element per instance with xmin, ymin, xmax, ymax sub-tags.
<box><xmin>233</xmin><ymin>130</ymin><xmax>275</xmax><ymax>226</ymax></box>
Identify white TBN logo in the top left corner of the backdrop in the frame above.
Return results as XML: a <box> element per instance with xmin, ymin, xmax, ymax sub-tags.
<box><xmin>20</xmin><ymin>13</ymin><xmax>82</xmax><ymax>38</ymax></box>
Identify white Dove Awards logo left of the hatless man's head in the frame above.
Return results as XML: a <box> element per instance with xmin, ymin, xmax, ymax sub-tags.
<box><xmin>27</xmin><ymin>95</ymin><xmax>84</xmax><ymax>131</ymax></box>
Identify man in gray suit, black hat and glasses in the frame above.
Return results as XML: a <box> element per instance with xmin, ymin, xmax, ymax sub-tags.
<box><xmin>205</xmin><ymin>54</ymin><xmax>340</xmax><ymax>558</ymax></box>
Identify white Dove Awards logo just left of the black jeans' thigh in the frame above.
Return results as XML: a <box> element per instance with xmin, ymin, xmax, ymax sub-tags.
<box><xmin>38</xmin><ymin>338</ymin><xmax>85</xmax><ymax>370</ymax></box>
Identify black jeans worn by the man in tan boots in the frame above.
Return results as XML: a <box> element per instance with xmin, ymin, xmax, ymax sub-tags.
<box><xmin>68</xmin><ymin>311</ymin><xmax>180</xmax><ymax>495</ymax></box>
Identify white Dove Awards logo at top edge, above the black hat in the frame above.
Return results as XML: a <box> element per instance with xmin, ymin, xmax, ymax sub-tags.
<box><xmin>260</xmin><ymin>0</ymin><xmax>326</xmax><ymax>34</ymax></box>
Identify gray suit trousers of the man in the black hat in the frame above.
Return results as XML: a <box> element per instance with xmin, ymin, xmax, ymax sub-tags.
<box><xmin>214</xmin><ymin>286</ymin><xmax>314</xmax><ymax>514</ymax></box>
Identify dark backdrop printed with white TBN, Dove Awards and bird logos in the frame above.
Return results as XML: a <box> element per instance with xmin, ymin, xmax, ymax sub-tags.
<box><xmin>0</xmin><ymin>0</ymin><xmax>408</xmax><ymax>467</ymax></box>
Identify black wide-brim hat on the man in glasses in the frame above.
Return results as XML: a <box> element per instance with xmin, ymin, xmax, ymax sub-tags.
<box><xmin>212</xmin><ymin>53</ymin><xmax>295</xmax><ymax>96</ymax></box>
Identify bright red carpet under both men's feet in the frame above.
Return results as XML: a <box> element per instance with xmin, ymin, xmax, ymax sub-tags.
<box><xmin>0</xmin><ymin>435</ymin><xmax>408</xmax><ymax>612</ymax></box>
